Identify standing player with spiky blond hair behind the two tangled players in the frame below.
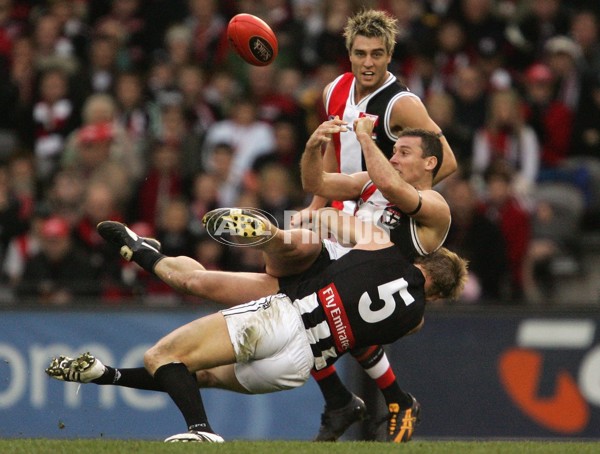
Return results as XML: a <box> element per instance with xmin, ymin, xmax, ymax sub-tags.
<box><xmin>292</xmin><ymin>10</ymin><xmax>457</xmax><ymax>441</ymax></box>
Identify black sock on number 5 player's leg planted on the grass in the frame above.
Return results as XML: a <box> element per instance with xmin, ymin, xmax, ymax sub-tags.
<box><xmin>154</xmin><ymin>363</ymin><xmax>214</xmax><ymax>433</ymax></box>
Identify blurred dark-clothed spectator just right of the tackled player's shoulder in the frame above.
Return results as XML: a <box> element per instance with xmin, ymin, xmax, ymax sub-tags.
<box><xmin>444</xmin><ymin>175</ymin><xmax>508</xmax><ymax>303</ymax></box>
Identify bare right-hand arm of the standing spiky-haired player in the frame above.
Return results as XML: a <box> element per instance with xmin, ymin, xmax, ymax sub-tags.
<box><xmin>390</xmin><ymin>96</ymin><xmax>458</xmax><ymax>185</ymax></box>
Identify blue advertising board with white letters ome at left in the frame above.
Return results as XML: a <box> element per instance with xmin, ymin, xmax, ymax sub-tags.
<box><xmin>0</xmin><ymin>311</ymin><xmax>323</xmax><ymax>440</ymax></box>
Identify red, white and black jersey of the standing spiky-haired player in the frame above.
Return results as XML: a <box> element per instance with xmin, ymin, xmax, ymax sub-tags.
<box><xmin>325</xmin><ymin>73</ymin><xmax>416</xmax><ymax>214</ymax></box>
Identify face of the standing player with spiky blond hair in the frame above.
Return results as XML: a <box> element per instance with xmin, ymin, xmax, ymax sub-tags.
<box><xmin>350</xmin><ymin>35</ymin><xmax>392</xmax><ymax>94</ymax></box>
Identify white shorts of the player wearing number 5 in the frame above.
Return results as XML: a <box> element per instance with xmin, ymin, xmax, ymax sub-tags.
<box><xmin>221</xmin><ymin>294</ymin><xmax>314</xmax><ymax>394</ymax></box>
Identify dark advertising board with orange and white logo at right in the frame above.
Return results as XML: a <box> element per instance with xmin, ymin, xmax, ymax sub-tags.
<box><xmin>388</xmin><ymin>310</ymin><xmax>600</xmax><ymax>439</ymax></box>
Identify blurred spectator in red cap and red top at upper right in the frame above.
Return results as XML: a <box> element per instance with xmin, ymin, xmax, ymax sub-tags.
<box><xmin>524</xmin><ymin>63</ymin><xmax>573</xmax><ymax>169</ymax></box>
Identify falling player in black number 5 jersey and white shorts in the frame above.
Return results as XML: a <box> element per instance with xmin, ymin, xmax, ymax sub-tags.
<box><xmin>46</xmin><ymin>211</ymin><xmax>466</xmax><ymax>443</ymax></box>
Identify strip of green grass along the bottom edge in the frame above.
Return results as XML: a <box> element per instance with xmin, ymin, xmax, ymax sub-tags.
<box><xmin>0</xmin><ymin>439</ymin><xmax>600</xmax><ymax>454</ymax></box>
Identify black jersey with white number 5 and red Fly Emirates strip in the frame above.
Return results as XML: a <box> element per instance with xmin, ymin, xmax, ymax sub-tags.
<box><xmin>293</xmin><ymin>246</ymin><xmax>425</xmax><ymax>370</ymax></box>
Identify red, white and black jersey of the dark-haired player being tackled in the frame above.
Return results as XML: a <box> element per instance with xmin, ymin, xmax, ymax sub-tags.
<box><xmin>354</xmin><ymin>180</ymin><xmax>449</xmax><ymax>262</ymax></box>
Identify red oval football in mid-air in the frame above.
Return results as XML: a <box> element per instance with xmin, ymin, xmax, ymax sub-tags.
<box><xmin>227</xmin><ymin>13</ymin><xmax>277</xmax><ymax>66</ymax></box>
